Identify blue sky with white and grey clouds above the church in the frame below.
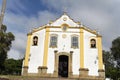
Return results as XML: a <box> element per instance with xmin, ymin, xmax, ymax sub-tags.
<box><xmin>0</xmin><ymin>0</ymin><xmax>120</xmax><ymax>59</ymax></box>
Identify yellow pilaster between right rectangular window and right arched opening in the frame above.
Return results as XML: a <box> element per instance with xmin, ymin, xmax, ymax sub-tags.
<box><xmin>80</xmin><ymin>28</ymin><xmax>84</xmax><ymax>68</ymax></box>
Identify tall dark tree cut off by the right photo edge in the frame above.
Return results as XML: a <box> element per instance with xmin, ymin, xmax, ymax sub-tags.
<box><xmin>111</xmin><ymin>37</ymin><xmax>120</xmax><ymax>69</ymax></box>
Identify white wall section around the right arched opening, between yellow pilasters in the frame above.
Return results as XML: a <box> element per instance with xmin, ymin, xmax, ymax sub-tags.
<box><xmin>84</xmin><ymin>30</ymin><xmax>98</xmax><ymax>76</ymax></box>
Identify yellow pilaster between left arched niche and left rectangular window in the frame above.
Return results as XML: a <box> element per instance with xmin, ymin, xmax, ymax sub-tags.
<box><xmin>43</xmin><ymin>28</ymin><xmax>50</xmax><ymax>67</ymax></box>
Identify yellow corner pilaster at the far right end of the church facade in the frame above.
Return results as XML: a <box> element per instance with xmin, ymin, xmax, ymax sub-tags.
<box><xmin>97</xmin><ymin>36</ymin><xmax>103</xmax><ymax>69</ymax></box>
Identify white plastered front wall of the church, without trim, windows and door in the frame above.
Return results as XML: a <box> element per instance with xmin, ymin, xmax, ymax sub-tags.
<box><xmin>23</xmin><ymin>14</ymin><xmax>105</xmax><ymax>76</ymax></box>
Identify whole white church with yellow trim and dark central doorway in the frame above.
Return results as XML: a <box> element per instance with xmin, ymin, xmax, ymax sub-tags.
<box><xmin>22</xmin><ymin>13</ymin><xmax>105</xmax><ymax>80</ymax></box>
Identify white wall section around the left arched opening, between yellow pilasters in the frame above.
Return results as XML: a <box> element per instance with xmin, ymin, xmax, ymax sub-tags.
<box><xmin>28</xmin><ymin>29</ymin><xmax>45</xmax><ymax>73</ymax></box>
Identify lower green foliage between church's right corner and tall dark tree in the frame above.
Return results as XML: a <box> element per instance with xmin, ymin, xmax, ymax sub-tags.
<box><xmin>103</xmin><ymin>51</ymin><xmax>120</xmax><ymax>80</ymax></box>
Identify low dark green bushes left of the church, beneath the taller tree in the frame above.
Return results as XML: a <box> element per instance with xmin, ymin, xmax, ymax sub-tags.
<box><xmin>4</xmin><ymin>59</ymin><xmax>23</xmax><ymax>75</ymax></box>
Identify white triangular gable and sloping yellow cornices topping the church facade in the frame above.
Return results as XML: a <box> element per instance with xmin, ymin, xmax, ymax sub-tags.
<box><xmin>29</xmin><ymin>13</ymin><xmax>100</xmax><ymax>36</ymax></box>
